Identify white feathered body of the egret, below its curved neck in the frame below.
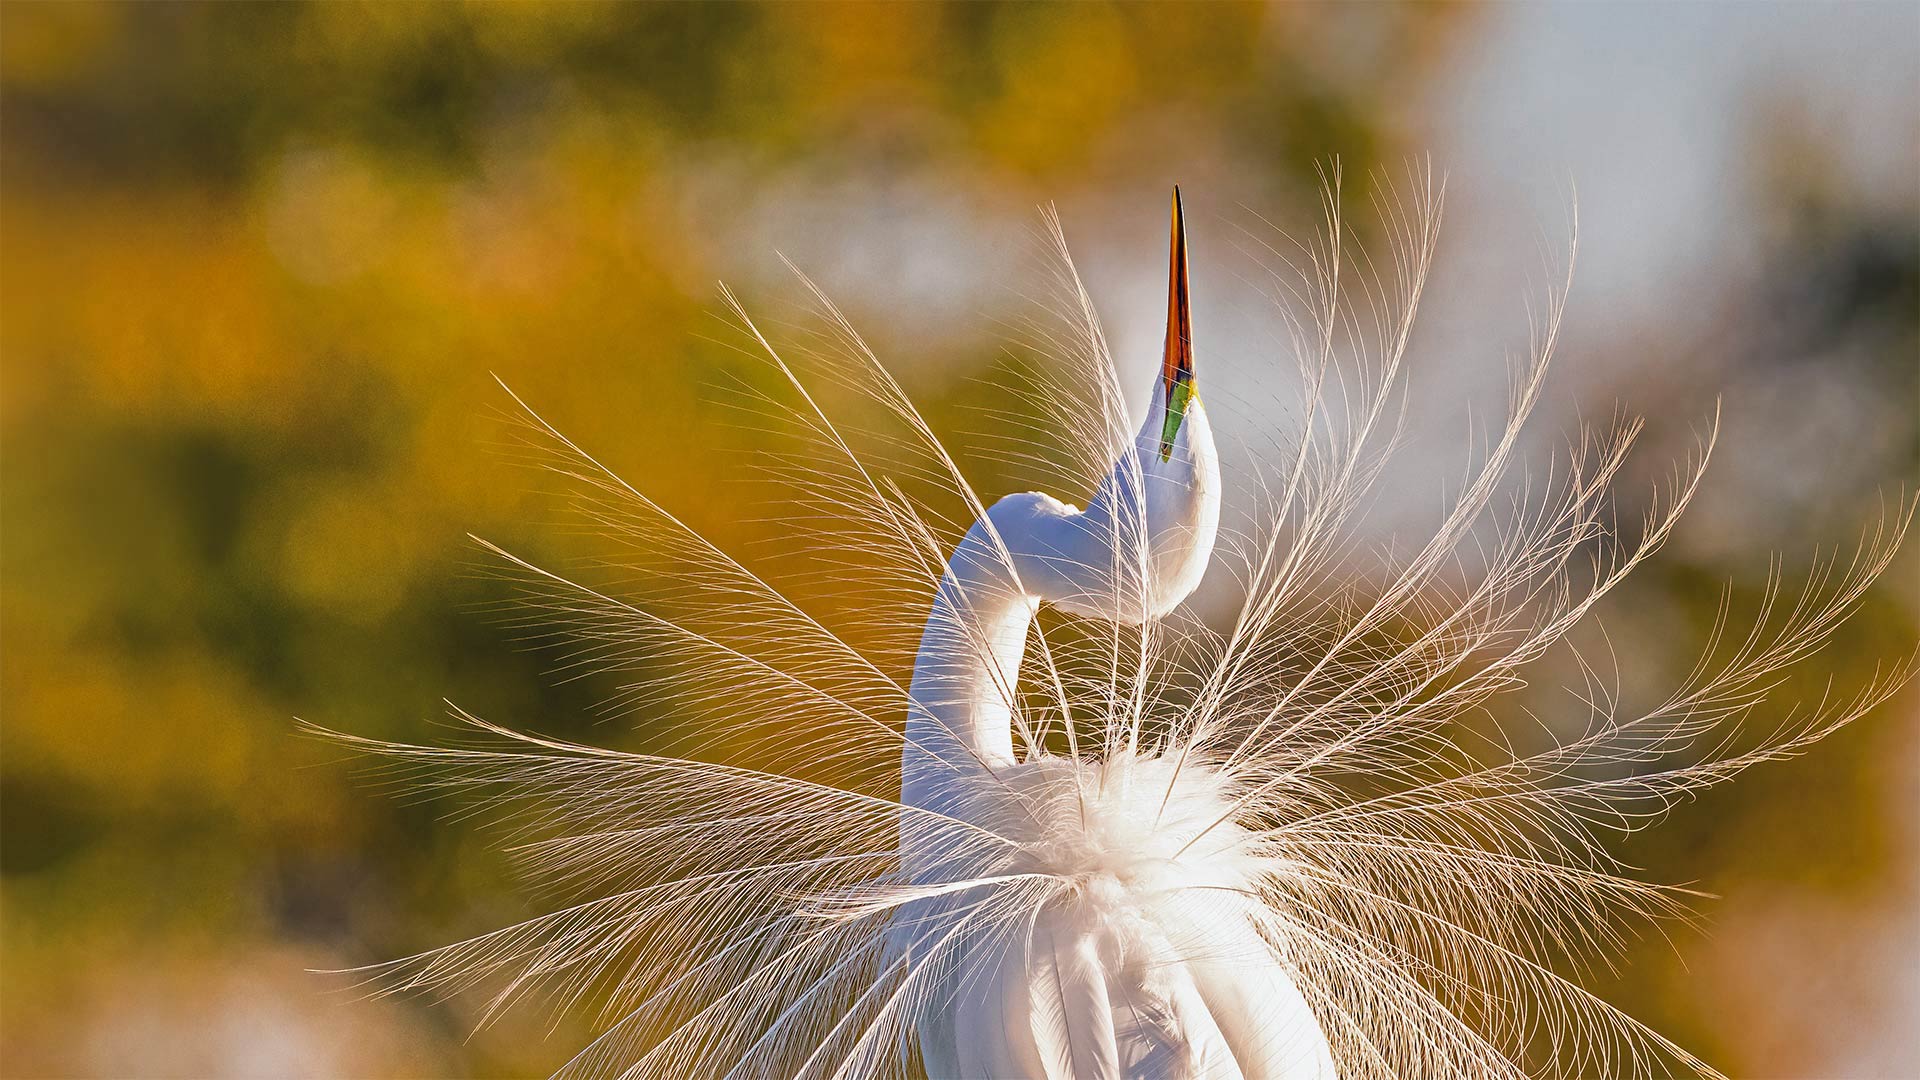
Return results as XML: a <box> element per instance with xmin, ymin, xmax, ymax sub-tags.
<box><xmin>902</xmin><ymin>753</ymin><xmax>1336</xmax><ymax>1080</ymax></box>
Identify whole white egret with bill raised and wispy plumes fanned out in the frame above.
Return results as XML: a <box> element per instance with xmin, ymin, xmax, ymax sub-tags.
<box><xmin>322</xmin><ymin>177</ymin><xmax>1912</xmax><ymax>1080</ymax></box>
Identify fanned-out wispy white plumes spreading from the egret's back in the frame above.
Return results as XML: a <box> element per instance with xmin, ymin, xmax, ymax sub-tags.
<box><xmin>307</xmin><ymin>171</ymin><xmax>1914</xmax><ymax>1078</ymax></box>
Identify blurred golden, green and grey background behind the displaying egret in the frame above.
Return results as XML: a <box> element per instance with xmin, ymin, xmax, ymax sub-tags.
<box><xmin>0</xmin><ymin>4</ymin><xmax>1920</xmax><ymax>1078</ymax></box>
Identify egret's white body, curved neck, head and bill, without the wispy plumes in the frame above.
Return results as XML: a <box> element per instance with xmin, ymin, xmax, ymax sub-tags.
<box><xmin>895</xmin><ymin>188</ymin><xmax>1334</xmax><ymax>1080</ymax></box>
